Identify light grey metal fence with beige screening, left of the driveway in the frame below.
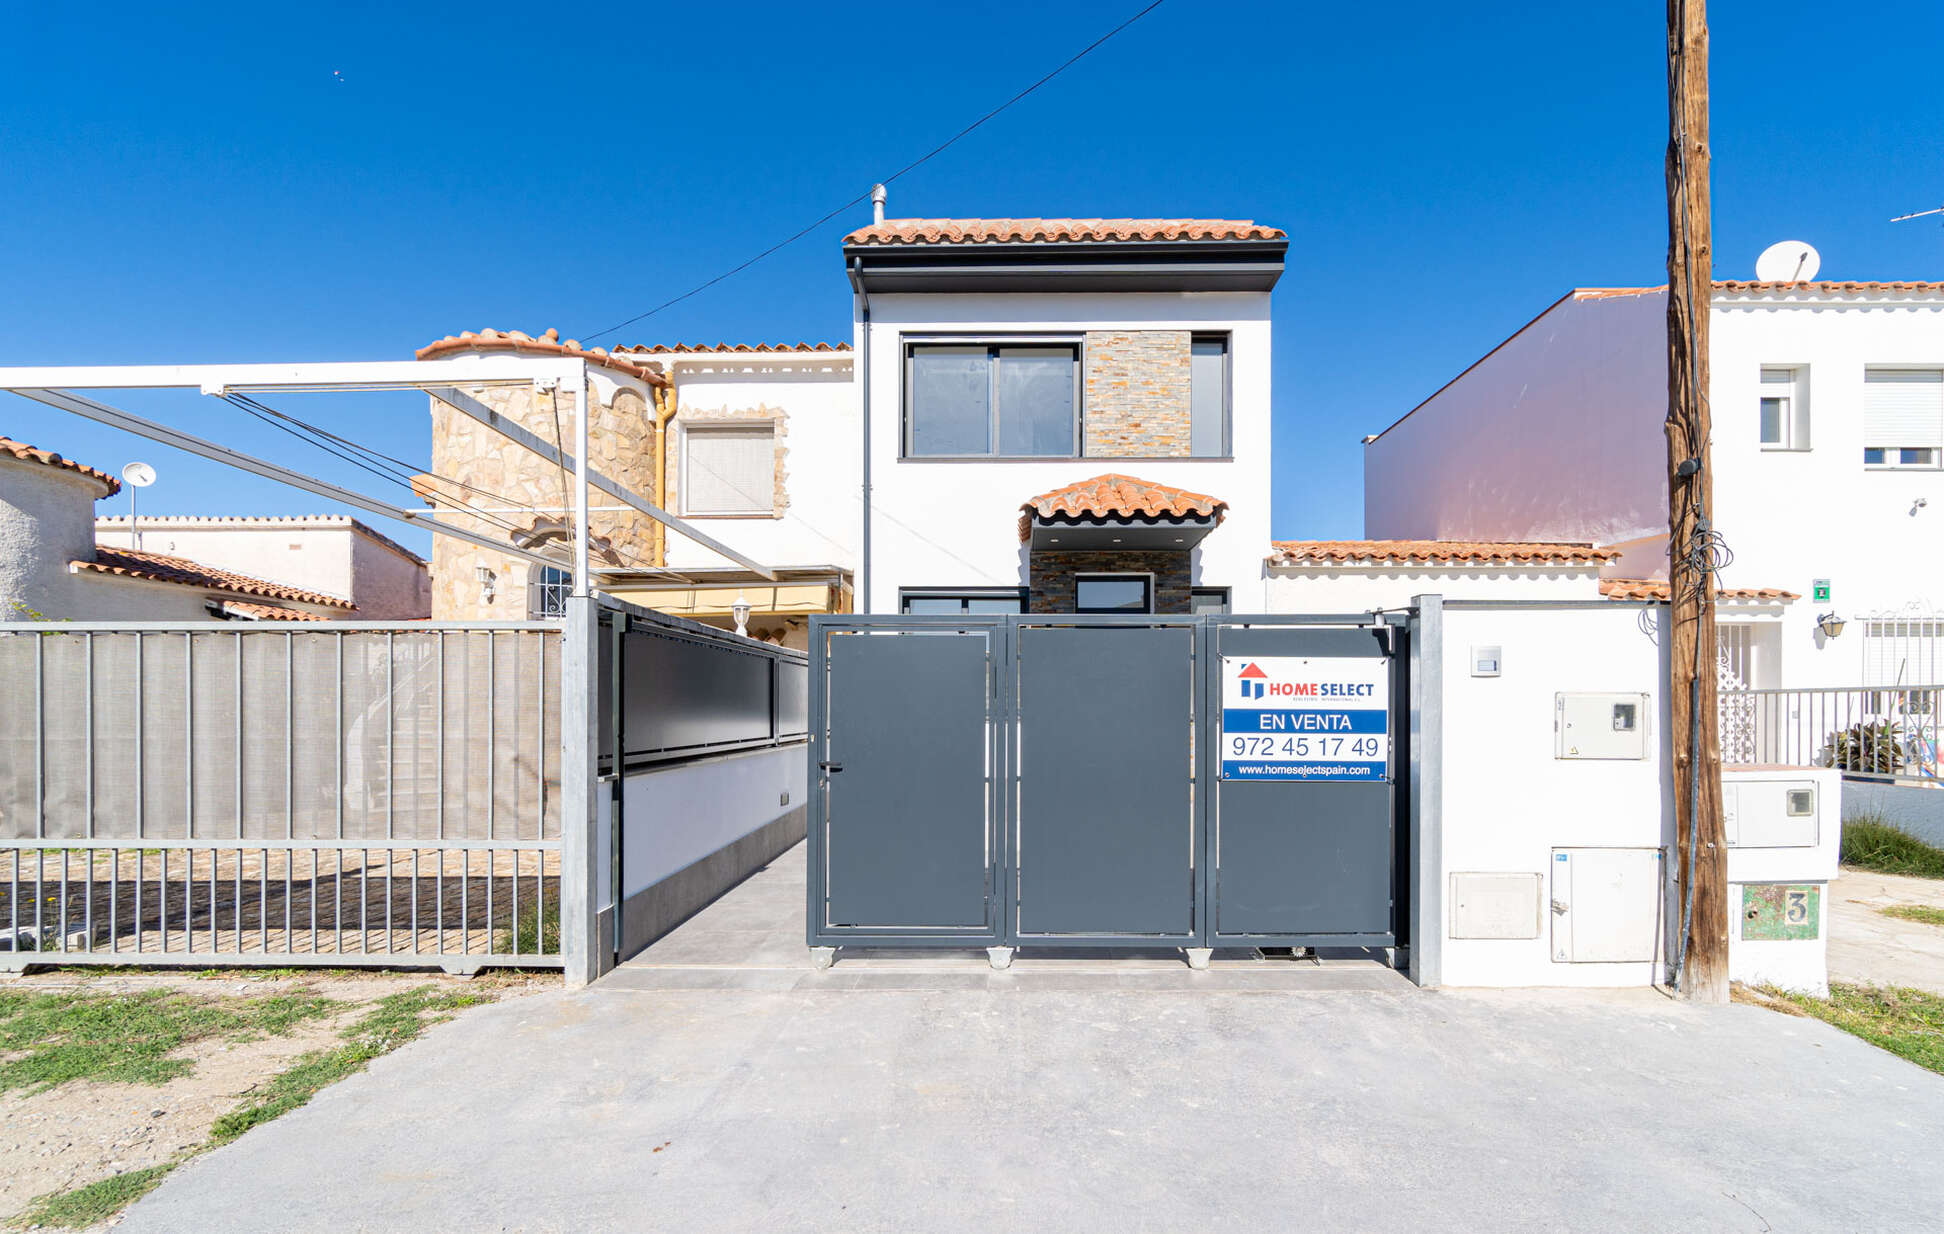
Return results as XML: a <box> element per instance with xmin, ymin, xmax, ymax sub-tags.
<box><xmin>0</xmin><ymin>622</ymin><xmax>560</xmax><ymax>970</ymax></box>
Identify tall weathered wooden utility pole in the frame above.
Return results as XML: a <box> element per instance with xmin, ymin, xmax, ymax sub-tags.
<box><xmin>1668</xmin><ymin>0</ymin><xmax>1728</xmax><ymax>1003</ymax></box>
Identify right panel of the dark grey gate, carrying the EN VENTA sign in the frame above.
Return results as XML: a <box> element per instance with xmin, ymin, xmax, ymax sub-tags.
<box><xmin>1205</xmin><ymin>624</ymin><xmax>1407</xmax><ymax>946</ymax></box>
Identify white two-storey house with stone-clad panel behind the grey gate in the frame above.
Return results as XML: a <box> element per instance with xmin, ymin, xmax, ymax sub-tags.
<box><xmin>844</xmin><ymin>218</ymin><xmax>1289</xmax><ymax>612</ymax></box>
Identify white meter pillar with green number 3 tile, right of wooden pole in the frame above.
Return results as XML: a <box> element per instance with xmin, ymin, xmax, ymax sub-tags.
<box><xmin>1720</xmin><ymin>766</ymin><xmax>1843</xmax><ymax>995</ymax></box>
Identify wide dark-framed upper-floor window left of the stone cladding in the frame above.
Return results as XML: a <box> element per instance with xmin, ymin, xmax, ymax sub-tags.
<box><xmin>904</xmin><ymin>340</ymin><xmax>1081</xmax><ymax>459</ymax></box>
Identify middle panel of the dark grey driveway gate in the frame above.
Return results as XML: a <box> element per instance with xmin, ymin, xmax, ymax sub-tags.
<box><xmin>1015</xmin><ymin>624</ymin><xmax>1198</xmax><ymax>941</ymax></box>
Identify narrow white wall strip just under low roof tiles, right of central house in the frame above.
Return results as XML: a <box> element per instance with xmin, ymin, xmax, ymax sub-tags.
<box><xmin>1267</xmin><ymin>564</ymin><xmax>1600</xmax><ymax>612</ymax></box>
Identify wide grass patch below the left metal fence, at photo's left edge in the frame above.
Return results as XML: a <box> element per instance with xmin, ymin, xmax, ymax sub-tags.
<box><xmin>0</xmin><ymin>991</ymin><xmax>336</xmax><ymax>1092</ymax></box>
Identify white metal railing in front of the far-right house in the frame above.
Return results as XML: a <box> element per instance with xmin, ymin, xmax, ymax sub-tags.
<box><xmin>1720</xmin><ymin>686</ymin><xmax>1944</xmax><ymax>781</ymax></box>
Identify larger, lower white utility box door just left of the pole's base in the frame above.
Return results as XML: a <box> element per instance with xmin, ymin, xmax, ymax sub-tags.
<box><xmin>1551</xmin><ymin>849</ymin><xmax>1664</xmax><ymax>964</ymax></box>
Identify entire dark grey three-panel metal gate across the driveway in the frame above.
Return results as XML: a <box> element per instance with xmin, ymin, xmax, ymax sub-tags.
<box><xmin>807</xmin><ymin>614</ymin><xmax>1409</xmax><ymax>948</ymax></box>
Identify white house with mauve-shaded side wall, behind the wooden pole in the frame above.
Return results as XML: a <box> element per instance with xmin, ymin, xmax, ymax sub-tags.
<box><xmin>1365</xmin><ymin>282</ymin><xmax>1944</xmax><ymax>688</ymax></box>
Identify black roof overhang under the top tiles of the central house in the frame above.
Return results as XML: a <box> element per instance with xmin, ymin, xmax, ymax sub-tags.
<box><xmin>844</xmin><ymin>239</ymin><xmax>1289</xmax><ymax>295</ymax></box>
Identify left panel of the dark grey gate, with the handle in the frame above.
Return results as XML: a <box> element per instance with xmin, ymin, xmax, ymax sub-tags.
<box><xmin>811</xmin><ymin>628</ymin><xmax>999</xmax><ymax>941</ymax></box>
